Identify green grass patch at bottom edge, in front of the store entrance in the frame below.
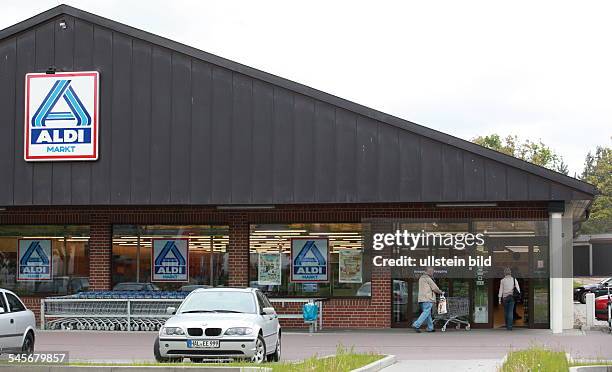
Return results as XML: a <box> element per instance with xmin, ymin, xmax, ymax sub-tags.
<box><xmin>500</xmin><ymin>346</ymin><xmax>569</xmax><ymax>372</ymax></box>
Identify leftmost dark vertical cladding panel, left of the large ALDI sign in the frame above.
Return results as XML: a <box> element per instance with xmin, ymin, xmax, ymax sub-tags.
<box><xmin>0</xmin><ymin>38</ymin><xmax>16</xmax><ymax>205</ymax></box>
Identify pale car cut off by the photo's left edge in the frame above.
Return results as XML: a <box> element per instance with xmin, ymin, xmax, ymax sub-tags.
<box><xmin>0</xmin><ymin>288</ymin><xmax>36</xmax><ymax>354</ymax></box>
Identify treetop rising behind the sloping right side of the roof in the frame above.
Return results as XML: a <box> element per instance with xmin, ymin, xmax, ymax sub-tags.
<box><xmin>472</xmin><ymin>134</ymin><xmax>569</xmax><ymax>175</ymax></box>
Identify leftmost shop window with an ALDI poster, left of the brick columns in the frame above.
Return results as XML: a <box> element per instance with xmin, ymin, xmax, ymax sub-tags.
<box><xmin>0</xmin><ymin>225</ymin><xmax>89</xmax><ymax>296</ymax></box>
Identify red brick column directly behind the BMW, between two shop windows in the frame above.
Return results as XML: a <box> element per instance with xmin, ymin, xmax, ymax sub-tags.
<box><xmin>228</xmin><ymin>213</ymin><xmax>249</xmax><ymax>287</ymax></box>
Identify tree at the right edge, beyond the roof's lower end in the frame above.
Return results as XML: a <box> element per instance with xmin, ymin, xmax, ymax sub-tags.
<box><xmin>580</xmin><ymin>147</ymin><xmax>612</xmax><ymax>234</ymax></box>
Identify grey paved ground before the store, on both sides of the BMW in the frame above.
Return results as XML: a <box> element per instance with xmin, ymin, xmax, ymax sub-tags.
<box><xmin>36</xmin><ymin>329</ymin><xmax>612</xmax><ymax>362</ymax></box>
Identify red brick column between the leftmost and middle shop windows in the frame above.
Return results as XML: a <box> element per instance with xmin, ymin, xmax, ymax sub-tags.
<box><xmin>89</xmin><ymin>213</ymin><xmax>113</xmax><ymax>291</ymax></box>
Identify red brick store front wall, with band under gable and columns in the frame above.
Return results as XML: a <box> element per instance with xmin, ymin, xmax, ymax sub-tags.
<box><xmin>0</xmin><ymin>202</ymin><xmax>548</xmax><ymax>328</ymax></box>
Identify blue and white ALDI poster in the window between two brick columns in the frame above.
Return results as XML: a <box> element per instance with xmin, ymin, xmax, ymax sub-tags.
<box><xmin>151</xmin><ymin>239</ymin><xmax>189</xmax><ymax>282</ymax></box>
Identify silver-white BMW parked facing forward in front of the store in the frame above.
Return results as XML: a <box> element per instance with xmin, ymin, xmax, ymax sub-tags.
<box><xmin>153</xmin><ymin>287</ymin><xmax>281</xmax><ymax>363</ymax></box>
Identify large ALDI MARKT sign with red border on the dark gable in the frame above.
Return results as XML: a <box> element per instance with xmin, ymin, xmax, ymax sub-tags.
<box><xmin>24</xmin><ymin>71</ymin><xmax>99</xmax><ymax>161</ymax></box>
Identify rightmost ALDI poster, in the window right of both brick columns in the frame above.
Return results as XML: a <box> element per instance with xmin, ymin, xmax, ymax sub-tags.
<box><xmin>291</xmin><ymin>238</ymin><xmax>329</xmax><ymax>283</ymax></box>
